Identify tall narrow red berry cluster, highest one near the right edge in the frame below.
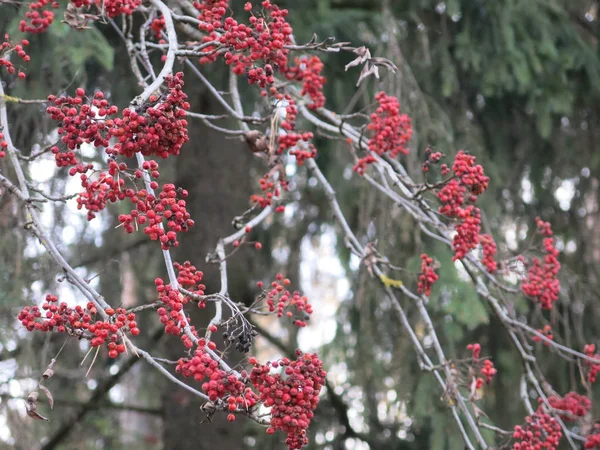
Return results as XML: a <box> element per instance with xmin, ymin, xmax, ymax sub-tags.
<box><xmin>521</xmin><ymin>217</ymin><xmax>560</xmax><ymax>309</ymax></box>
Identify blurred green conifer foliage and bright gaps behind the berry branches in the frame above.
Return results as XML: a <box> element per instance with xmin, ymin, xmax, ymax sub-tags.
<box><xmin>0</xmin><ymin>0</ymin><xmax>600</xmax><ymax>450</ymax></box>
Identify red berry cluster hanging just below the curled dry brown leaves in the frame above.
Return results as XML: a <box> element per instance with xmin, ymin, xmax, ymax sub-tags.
<box><xmin>354</xmin><ymin>92</ymin><xmax>412</xmax><ymax>175</ymax></box>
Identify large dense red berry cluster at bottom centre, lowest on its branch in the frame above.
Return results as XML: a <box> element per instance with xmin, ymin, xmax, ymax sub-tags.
<box><xmin>250</xmin><ymin>350</ymin><xmax>326</xmax><ymax>449</ymax></box>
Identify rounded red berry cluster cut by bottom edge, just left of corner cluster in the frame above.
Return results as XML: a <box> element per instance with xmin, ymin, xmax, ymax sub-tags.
<box><xmin>513</xmin><ymin>412</ymin><xmax>562</xmax><ymax>450</ymax></box>
